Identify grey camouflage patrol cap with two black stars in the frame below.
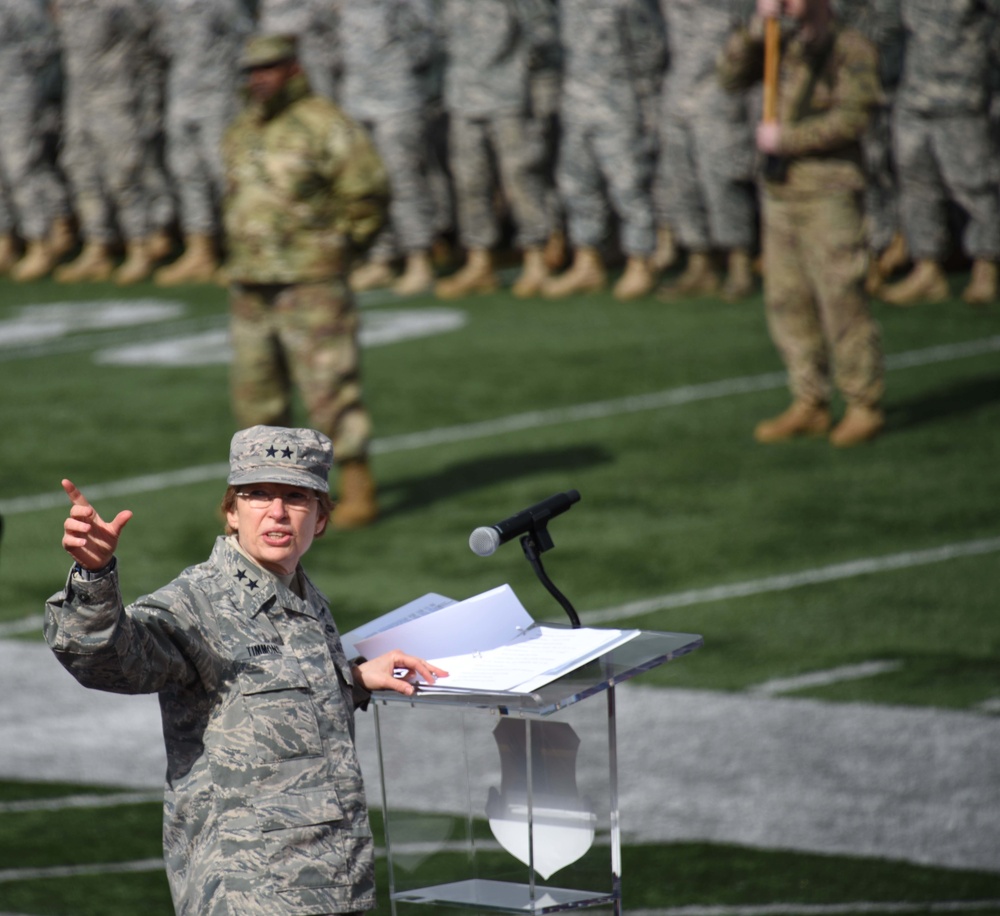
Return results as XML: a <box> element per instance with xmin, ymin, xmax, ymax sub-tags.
<box><xmin>227</xmin><ymin>426</ymin><xmax>333</xmax><ymax>493</ymax></box>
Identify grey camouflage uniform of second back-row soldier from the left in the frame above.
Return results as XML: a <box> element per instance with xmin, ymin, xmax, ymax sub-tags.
<box><xmin>54</xmin><ymin>0</ymin><xmax>160</xmax><ymax>242</ymax></box>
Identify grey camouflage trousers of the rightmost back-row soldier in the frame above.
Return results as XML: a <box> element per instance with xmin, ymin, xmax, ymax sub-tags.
<box><xmin>893</xmin><ymin>107</ymin><xmax>1000</xmax><ymax>261</ymax></box>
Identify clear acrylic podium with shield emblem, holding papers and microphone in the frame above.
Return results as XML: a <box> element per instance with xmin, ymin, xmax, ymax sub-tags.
<box><xmin>372</xmin><ymin>631</ymin><xmax>702</xmax><ymax>916</ymax></box>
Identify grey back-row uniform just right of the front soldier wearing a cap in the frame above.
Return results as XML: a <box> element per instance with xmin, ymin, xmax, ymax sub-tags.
<box><xmin>340</xmin><ymin>0</ymin><xmax>434</xmax><ymax>261</ymax></box>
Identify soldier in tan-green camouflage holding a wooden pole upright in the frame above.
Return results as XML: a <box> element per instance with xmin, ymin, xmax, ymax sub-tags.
<box><xmin>719</xmin><ymin>0</ymin><xmax>884</xmax><ymax>446</ymax></box>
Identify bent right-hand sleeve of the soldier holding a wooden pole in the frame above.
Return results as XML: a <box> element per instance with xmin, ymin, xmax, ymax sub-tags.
<box><xmin>779</xmin><ymin>33</ymin><xmax>881</xmax><ymax>156</ymax></box>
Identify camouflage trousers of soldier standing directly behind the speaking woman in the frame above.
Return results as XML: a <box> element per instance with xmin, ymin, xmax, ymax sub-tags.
<box><xmin>229</xmin><ymin>278</ymin><xmax>371</xmax><ymax>462</ymax></box>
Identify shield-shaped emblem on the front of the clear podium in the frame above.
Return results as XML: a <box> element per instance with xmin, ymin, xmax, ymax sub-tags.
<box><xmin>486</xmin><ymin>718</ymin><xmax>597</xmax><ymax>880</ymax></box>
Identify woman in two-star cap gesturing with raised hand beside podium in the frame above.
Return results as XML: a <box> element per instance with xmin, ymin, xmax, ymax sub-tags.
<box><xmin>45</xmin><ymin>427</ymin><xmax>445</xmax><ymax>916</ymax></box>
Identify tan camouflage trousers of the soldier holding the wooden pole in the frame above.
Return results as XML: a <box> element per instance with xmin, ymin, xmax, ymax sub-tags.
<box><xmin>763</xmin><ymin>190</ymin><xmax>885</xmax><ymax>406</ymax></box>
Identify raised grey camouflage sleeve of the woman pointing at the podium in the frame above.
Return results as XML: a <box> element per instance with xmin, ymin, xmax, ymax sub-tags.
<box><xmin>45</xmin><ymin>569</ymin><xmax>197</xmax><ymax>694</ymax></box>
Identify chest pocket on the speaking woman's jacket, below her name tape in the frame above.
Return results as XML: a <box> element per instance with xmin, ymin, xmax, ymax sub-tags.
<box><xmin>239</xmin><ymin>655</ymin><xmax>323</xmax><ymax>763</ymax></box>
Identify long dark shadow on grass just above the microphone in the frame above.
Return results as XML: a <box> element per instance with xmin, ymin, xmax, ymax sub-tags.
<box><xmin>379</xmin><ymin>446</ymin><xmax>614</xmax><ymax>518</ymax></box>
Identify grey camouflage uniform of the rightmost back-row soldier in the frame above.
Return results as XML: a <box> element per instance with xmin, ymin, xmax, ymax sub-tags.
<box><xmin>893</xmin><ymin>0</ymin><xmax>1000</xmax><ymax>261</ymax></box>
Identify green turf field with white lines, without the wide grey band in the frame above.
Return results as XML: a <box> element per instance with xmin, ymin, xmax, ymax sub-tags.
<box><xmin>0</xmin><ymin>275</ymin><xmax>1000</xmax><ymax>916</ymax></box>
